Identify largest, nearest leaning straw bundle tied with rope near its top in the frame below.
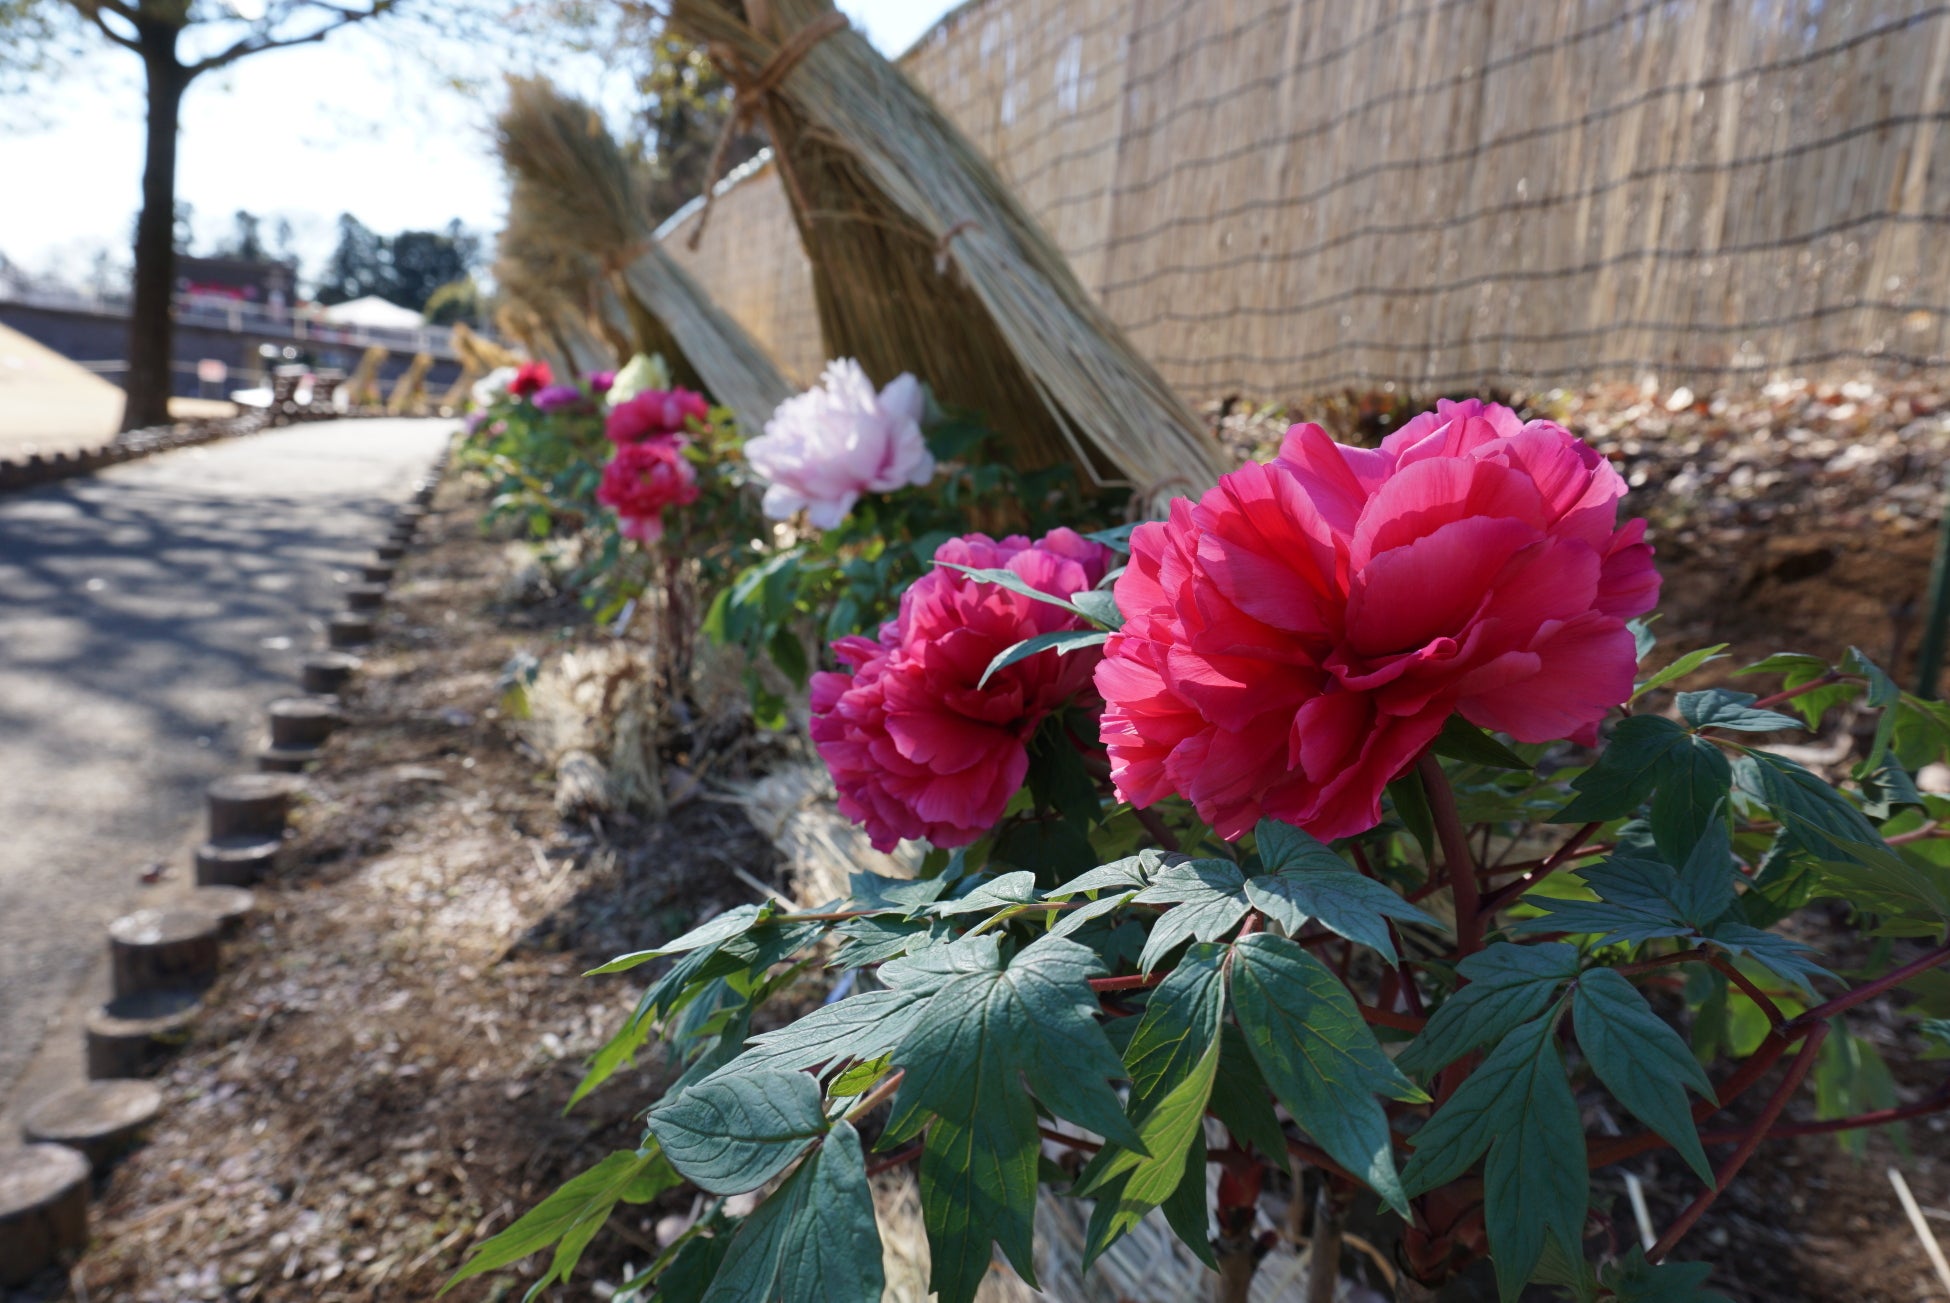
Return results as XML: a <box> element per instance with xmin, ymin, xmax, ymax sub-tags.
<box><xmin>671</xmin><ymin>0</ymin><xmax>1221</xmax><ymax>497</ymax></box>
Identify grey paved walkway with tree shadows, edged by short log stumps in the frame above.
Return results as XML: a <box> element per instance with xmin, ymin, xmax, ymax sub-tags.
<box><xmin>0</xmin><ymin>419</ymin><xmax>452</xmax><ymax>1100</ymax></box>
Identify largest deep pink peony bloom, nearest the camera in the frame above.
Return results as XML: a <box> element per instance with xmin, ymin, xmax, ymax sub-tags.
<box><xmin>1096</xmin><ymin>400</ymin><xmax>1659</xmax><ymax>839</ymax></box>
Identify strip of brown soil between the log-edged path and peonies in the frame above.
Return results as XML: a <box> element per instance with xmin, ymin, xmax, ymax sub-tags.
<box><xmin>38</xmin><ymin>473</ymin><xmax>774</xmax><ymax>1303</ymax></box>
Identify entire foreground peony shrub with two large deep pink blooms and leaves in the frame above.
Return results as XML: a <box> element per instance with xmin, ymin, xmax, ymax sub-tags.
<box><xmin>456</xmin><ymin>392</ymin><xmax>1950</xmax><ymax>1303</ymax></box>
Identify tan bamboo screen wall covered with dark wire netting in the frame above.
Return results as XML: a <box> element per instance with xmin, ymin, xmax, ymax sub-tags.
<box><xmin>671</xmin><ymin>0</ymin><xmax>1950</xmax><ymax>400</ymax></box>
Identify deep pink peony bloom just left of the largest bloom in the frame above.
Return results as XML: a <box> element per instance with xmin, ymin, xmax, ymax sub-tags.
<box><xmin>811</xmin><ymin>529</ymin><xmax>1113</xmax><ymax>850</ymax></box>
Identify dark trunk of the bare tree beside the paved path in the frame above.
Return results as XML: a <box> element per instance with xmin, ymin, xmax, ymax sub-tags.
<box><xmin>121</xmin><ymin>23</ymin><xmax>189</xmax><ymax>429</ymax></box>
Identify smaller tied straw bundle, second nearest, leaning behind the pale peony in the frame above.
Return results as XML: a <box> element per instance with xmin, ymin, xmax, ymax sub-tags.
<box><xmin>497</xmin><ymin>78</ymin><xmax>792</xmax><ymax>431</ymax></box>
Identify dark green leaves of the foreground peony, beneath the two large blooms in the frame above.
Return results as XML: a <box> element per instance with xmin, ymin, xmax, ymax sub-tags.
<box><xmin>456</xmin><ymin>553</ymin><xmax>1950</xmax><ymax>1303</ymax></box>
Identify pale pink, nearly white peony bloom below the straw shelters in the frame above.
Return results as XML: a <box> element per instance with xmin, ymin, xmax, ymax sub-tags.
<box><xmin>745</xmin><ymin>357</ymin><xmax>934</xmax><ymax>529</ymax></box>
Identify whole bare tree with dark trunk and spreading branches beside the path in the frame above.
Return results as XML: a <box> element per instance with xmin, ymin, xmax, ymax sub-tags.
<box><xmin>0</xmin><ymin>0</ymin><xmax>404</xmax><ymax>429</ymax></box>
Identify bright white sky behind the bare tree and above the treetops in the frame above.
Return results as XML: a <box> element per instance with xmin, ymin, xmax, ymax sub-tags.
<box><xmin>0</xmin><ymin>0</ymin><xmax>954</xmax><ymax>290</ymax></box>
